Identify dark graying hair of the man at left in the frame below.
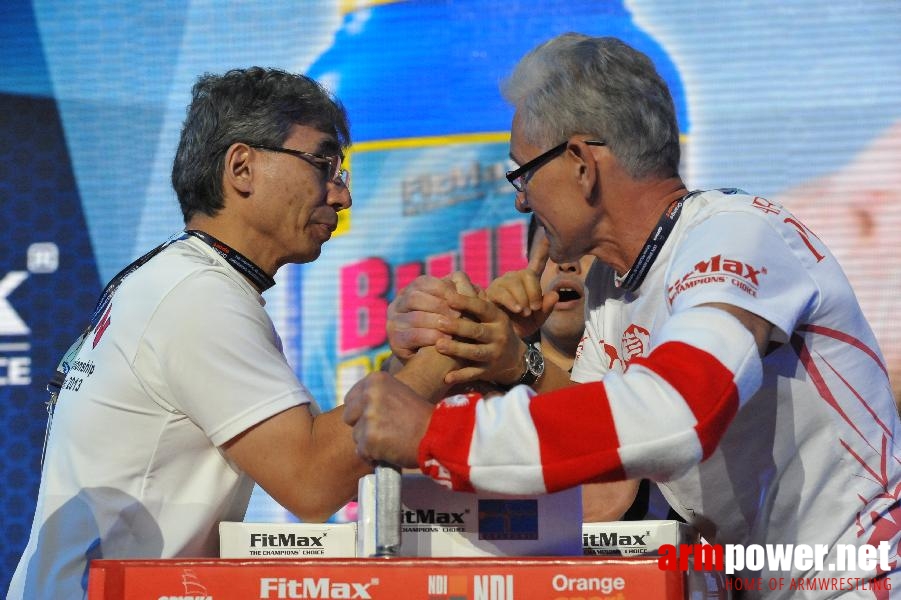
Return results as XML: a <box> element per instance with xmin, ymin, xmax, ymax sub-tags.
<box><xmin>172</xmin><ymin>67</ymin><xmax>350</xmax><ymax>222</ymax></box>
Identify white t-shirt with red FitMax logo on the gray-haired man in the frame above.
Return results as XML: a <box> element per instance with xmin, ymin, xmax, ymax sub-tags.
<box><xmin>572</xmin><ymin>191</ymin><xmax>901</xmax><ymax>598</ymax></box>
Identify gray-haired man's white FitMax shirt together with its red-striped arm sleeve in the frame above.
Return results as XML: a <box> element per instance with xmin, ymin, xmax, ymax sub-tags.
<box><xmin>420</xmin><ymin>190</ymin><xmax>901</xmax><ymax>598</ymax></box>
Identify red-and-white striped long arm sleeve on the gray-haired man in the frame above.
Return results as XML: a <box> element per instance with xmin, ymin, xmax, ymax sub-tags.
<box><xmin>419</xmin><ymin>306</ymin><xmax>762</xmax><ymax>494</ymax></box>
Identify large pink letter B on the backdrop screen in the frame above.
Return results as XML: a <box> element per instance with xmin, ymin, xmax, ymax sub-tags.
<box><xmin>338</xmin><ymin>258</ymin><xmax>390</xmax><ymax>354</ymax></box>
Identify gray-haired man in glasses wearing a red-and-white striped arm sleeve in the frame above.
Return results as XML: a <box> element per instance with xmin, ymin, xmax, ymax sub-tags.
<box><xmin>345</xmin><ymin>34</ymin><xmax>901</xmax><ymax>598</ymax></box>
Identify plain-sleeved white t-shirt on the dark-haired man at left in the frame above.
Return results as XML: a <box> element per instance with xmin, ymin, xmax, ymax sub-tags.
<box><xmin>9</xmin><ymin>238</ymin><xmax>312</xmax><ymax>600</ymax></box>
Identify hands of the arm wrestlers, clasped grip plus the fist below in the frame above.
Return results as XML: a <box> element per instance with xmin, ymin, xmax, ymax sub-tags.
<box><xmin>344</xmin><ymin>242</ymin><xmax>558</xmax><ymax>467</ymax></box>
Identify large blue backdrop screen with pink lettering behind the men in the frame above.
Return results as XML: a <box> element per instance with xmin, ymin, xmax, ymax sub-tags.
<box><xmin>0</xmin><ymin>0</ymin><xmax>901</xmax><ymax>593</ymax></box>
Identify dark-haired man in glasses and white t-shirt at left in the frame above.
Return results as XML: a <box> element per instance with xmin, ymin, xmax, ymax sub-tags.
<box><xmin>9</xmin><ymin>68</ymin><xmax>442</xmax><ymax>600</ymax></box>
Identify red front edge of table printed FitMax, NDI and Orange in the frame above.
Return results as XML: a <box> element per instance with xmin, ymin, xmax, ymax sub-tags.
<box><xmin>88</xmin><ymin>558</ymin><xmax>688</xmax><ymax>600</ymax></box>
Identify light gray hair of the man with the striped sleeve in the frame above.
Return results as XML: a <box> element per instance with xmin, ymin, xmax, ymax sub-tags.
<box><xmin>501</xmin><ymin>33</ymin><xmax>680</xmax><ymax>179</ymax></box>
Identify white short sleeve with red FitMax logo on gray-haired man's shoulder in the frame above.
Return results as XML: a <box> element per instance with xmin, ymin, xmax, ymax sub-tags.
<box><xmin>664</xmin><ymin>190</ymin><xmax>828</xmax><ymax>338</ymax></box>
